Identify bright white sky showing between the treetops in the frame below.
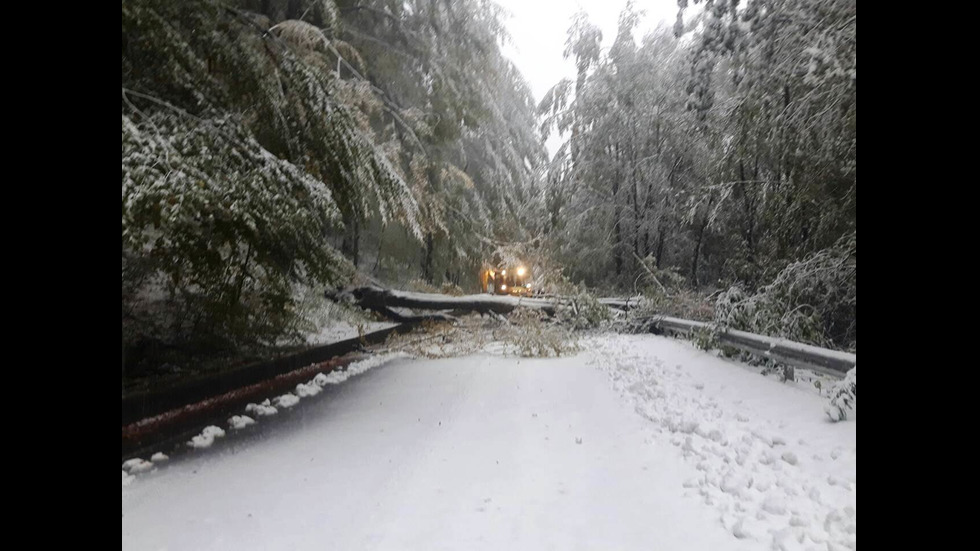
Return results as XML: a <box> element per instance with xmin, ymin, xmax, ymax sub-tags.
<box><xmin>494</xmin><ymin>0</ymin><xmax>677</xmax><ymax>154</ymax></box>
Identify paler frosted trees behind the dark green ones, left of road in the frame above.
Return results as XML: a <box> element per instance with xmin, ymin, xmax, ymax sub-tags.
<box><xmin>290</xmin><ymin>0</ymin><xmax>544</xmax><ymax>287</ymax></box>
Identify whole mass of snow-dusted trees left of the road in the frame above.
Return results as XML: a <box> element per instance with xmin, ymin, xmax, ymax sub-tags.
<box><xmin>122</xmin><ymin>0</ymin><xmax>543</xmax><ymax>363</ymax></box>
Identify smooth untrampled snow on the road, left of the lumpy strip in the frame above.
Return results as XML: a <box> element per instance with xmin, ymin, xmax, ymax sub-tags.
<box><xmin>122</xmin><ymin>354</ymin><xmax>752</xmax><ymax>551</ymax></box>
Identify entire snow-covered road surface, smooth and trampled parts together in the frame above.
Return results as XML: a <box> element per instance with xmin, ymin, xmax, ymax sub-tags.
<box><xmin>122</xmin><ymin>335</ymin><xmax>856</xmax><ymax>550</ymax></box>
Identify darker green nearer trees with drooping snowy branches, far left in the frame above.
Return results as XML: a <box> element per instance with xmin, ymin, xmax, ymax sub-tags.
<box><xmin>122</xmin><ymin>0</ymin><xmax>421</xmax><ymax>362</ymax></box>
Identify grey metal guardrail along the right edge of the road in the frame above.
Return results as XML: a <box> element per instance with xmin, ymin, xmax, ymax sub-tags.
<box><xmin>650</xmin><ymin>316</ymin><xmax>857</xmax><ymax>378</ymax></box>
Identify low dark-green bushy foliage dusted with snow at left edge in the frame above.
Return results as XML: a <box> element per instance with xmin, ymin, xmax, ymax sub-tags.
<box><xmin>122</xmin><ymin>113</ymin><xmax>351</xmax><ymax>350</ymax></box>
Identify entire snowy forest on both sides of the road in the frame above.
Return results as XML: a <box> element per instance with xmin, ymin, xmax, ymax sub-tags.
<box><xmin>122</xmin><ymin>0</ymin><xmax>857</xmax><ymax>376</ymax></box>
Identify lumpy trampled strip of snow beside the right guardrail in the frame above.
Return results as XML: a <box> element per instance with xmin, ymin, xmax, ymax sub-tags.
<box><xmin>583</xmin><ymin>335</ymin><xmax>857</xmax><ymax>551</ymax></box>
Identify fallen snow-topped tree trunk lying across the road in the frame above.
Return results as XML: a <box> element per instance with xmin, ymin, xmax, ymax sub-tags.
<box><xmin>325</xmin><ymin>286</ymin><xmax>557</xmax><ymax>321</ymax></box>
